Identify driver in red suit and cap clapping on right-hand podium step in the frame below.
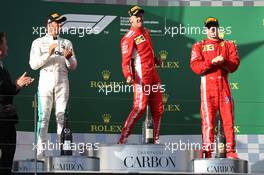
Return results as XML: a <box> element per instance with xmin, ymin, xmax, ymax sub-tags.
<box><xmin>190</xmin><ymin>17</ymin><xmax>240</xmax><ymax>159</ymax></box>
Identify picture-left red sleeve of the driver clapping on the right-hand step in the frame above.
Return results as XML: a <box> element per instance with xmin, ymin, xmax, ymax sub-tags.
<box><xmin>190</xmin><ymin>44</ymin><xmax>213</xmax><ymax>75</ymax></box>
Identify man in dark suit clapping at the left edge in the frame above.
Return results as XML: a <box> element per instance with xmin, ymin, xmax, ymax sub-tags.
<box><xmin>0</xmin><ymin>32</ymin><xmax>33</xmax><ymax>175</ymax></box>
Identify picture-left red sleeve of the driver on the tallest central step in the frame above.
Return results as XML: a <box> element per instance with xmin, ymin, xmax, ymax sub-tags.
<box><xmin>121</xmin><ymin>36</ymin><xmax>134</xmax><ymax>79</ymax></box>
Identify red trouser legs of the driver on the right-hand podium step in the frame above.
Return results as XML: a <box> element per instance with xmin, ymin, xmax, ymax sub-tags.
<box><xmin>201</xmin><ymin>76</ymin><xmax>235</xmax><ymax>157</ymax></box>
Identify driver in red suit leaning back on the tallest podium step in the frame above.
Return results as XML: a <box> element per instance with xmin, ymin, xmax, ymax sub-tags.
<box><xmin>118</xmin><ymin>6</ymin><xmax>163</xmax><ymax>144</ymax></box>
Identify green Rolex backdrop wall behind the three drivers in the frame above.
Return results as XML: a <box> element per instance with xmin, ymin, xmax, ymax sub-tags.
<box><xmin>0</xmin><ymin>1</ymin><xmax>264</xmax><ymax>134</ymax></box>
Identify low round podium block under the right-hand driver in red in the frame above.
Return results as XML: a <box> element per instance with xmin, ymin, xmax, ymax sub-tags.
<box><xmin>193</xmin><ymin>158</ymin><xmax>248</xmax><ymax>174</ymax></box>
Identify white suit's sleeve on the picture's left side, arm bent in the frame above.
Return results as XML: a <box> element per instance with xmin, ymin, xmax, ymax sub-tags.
<box><xmin>29</xmin><ymin>40</ymin><xmax>50</xmax><ymax>70</ymax></box>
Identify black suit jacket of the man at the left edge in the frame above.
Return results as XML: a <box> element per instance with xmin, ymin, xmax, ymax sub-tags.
<box><xmin>0</xmin><ymin>66</ymin><xmax>18</xmax><ymax>124</ymax></box>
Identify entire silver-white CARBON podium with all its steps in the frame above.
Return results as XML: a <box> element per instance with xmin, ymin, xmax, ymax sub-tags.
<box><xmin>14</xmin><ymin>144</ymin><xmax>252</xmax><ymax>174</ymax></box>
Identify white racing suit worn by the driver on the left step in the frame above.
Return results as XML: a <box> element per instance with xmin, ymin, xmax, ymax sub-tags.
<box><xmin>29</xmin><ymin>34</ymin><xmax>77</xmax><ymax>158</ymax></box>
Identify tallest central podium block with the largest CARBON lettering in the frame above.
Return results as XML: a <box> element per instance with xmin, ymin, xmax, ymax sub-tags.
<box><xmin>99</xmin><ymin>144</ymin><xmax>200</xmax><ymax>173</ymax></box>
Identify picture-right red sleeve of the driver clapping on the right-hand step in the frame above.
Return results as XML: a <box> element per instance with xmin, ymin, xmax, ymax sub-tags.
<box><xmin>224</xmin><ymin>42</ymin><xmax>240</xmax><ymax>73</ymax></box>
